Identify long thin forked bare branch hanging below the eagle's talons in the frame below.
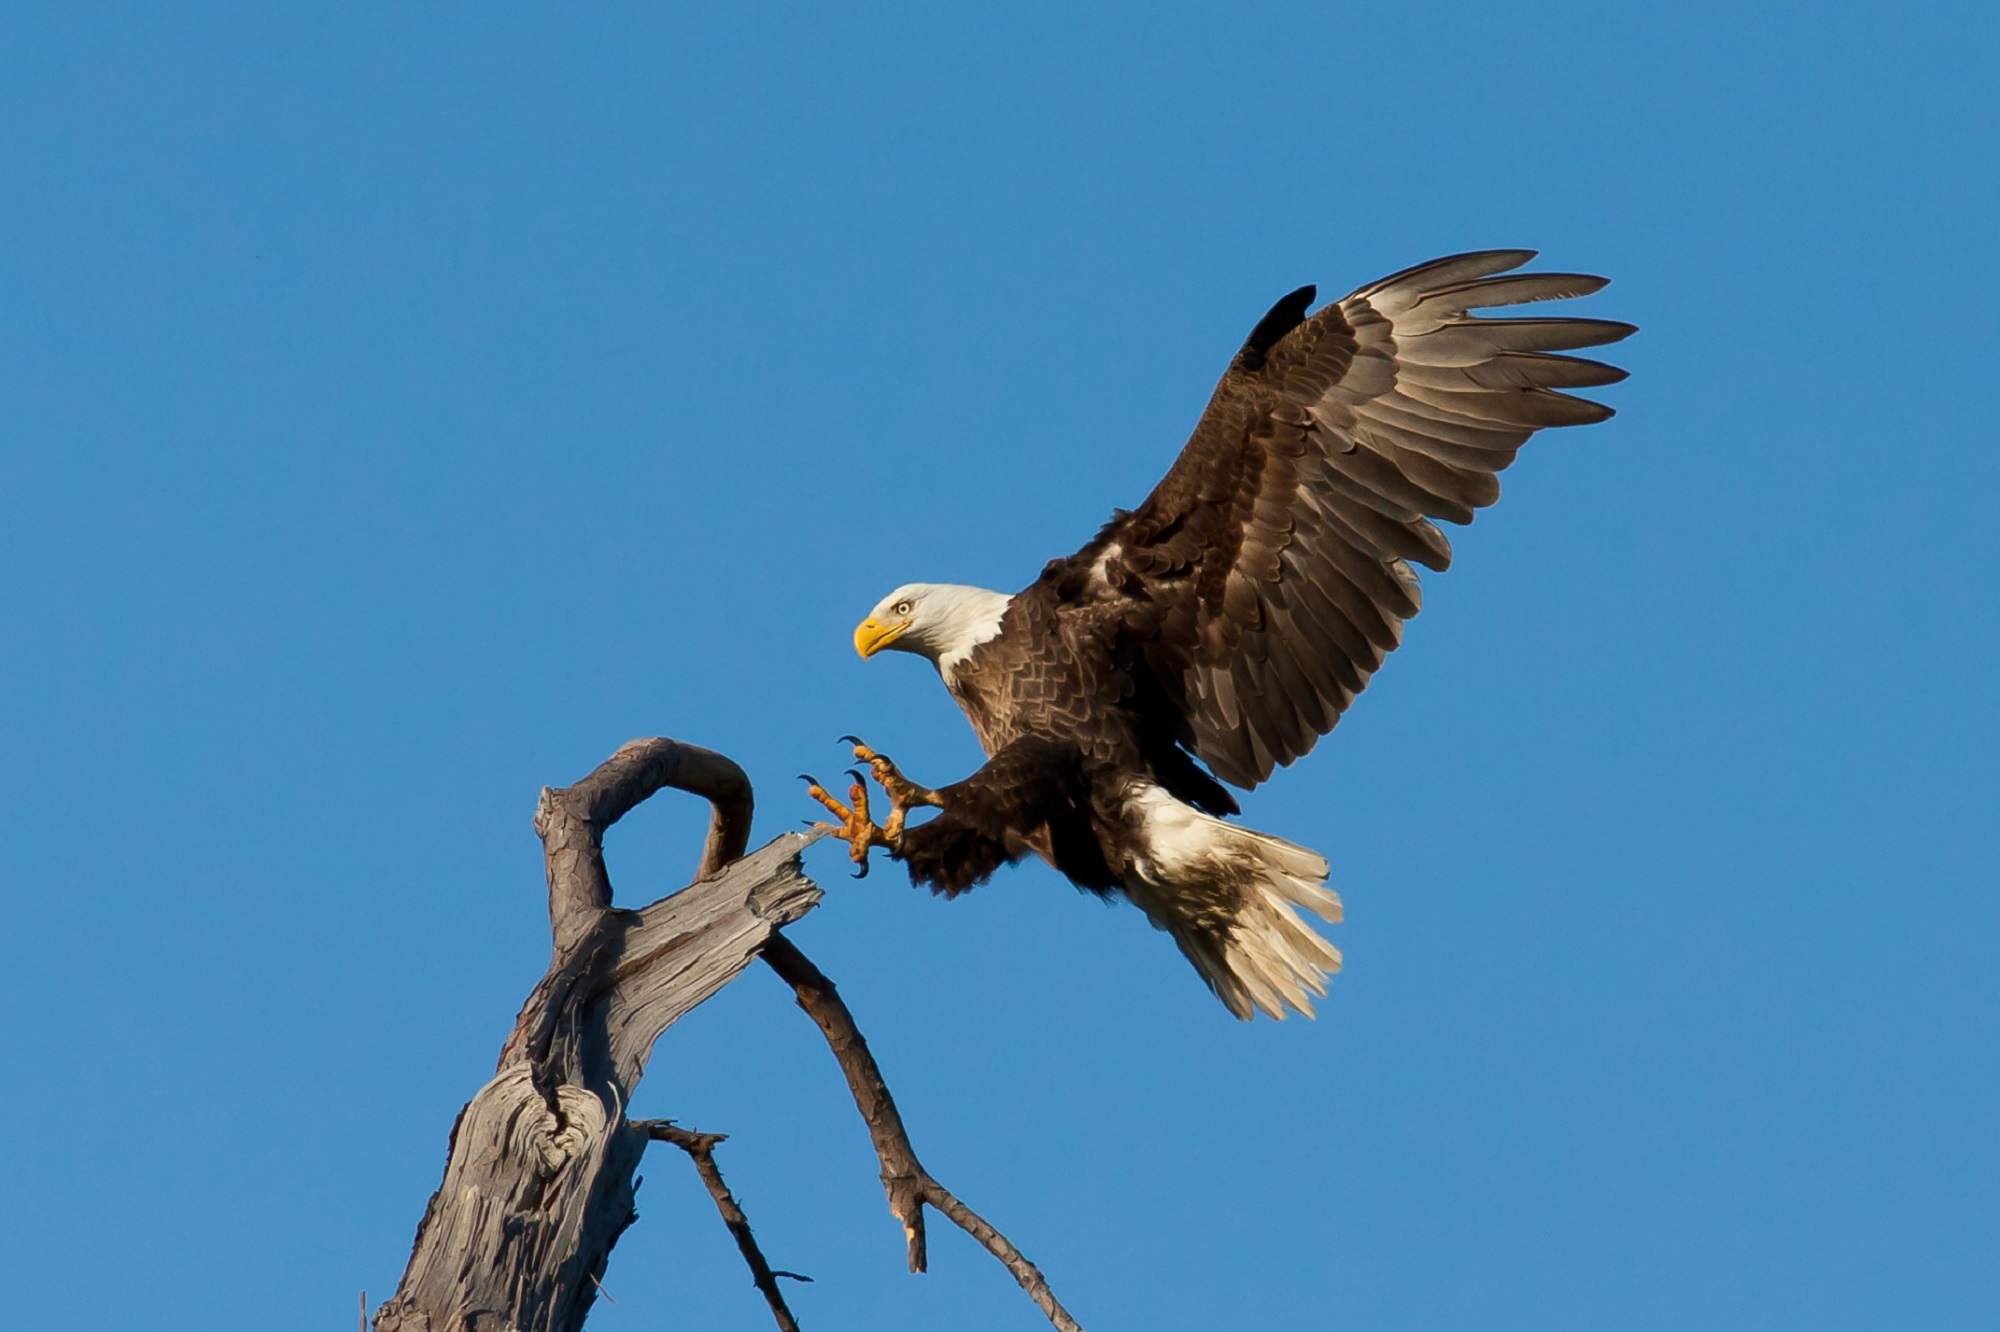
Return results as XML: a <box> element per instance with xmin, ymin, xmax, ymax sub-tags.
<box><xmin>764</xmin><ymin>932</ymin><xmax>1082</xmax><ymax>1332</ymax></box>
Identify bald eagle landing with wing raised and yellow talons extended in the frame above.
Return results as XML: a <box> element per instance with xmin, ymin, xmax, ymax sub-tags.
<box><xmin>808</xmin><ymin>250</ymin><xmax>1632</xmax><ymax>1018</ymax></box>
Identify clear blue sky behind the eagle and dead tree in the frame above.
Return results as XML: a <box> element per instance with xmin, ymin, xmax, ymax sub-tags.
<box><xmin>0</xmin><ymin>4</ymin><xmax>2000</xmax><ymax>1332</ymax></box>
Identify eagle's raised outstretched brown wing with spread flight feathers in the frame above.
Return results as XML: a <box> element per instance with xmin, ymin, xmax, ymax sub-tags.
<box><xmin>1062</xmin><ymin>250</ymin><xmax>1634</xmax><ymax>786</ymax></box>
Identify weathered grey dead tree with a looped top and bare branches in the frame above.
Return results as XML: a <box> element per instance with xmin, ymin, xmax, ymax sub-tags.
<box><xmin>374</xmin><ymin>740</ymin><xmax>1080</xmax><ymax>1332</ymax></box>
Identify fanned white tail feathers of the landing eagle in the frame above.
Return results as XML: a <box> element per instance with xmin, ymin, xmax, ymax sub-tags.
<box><xmin>1126</xmin><ymin>786</ymin><xmax>1340</xmax><ymax>1018</ymax></box>
